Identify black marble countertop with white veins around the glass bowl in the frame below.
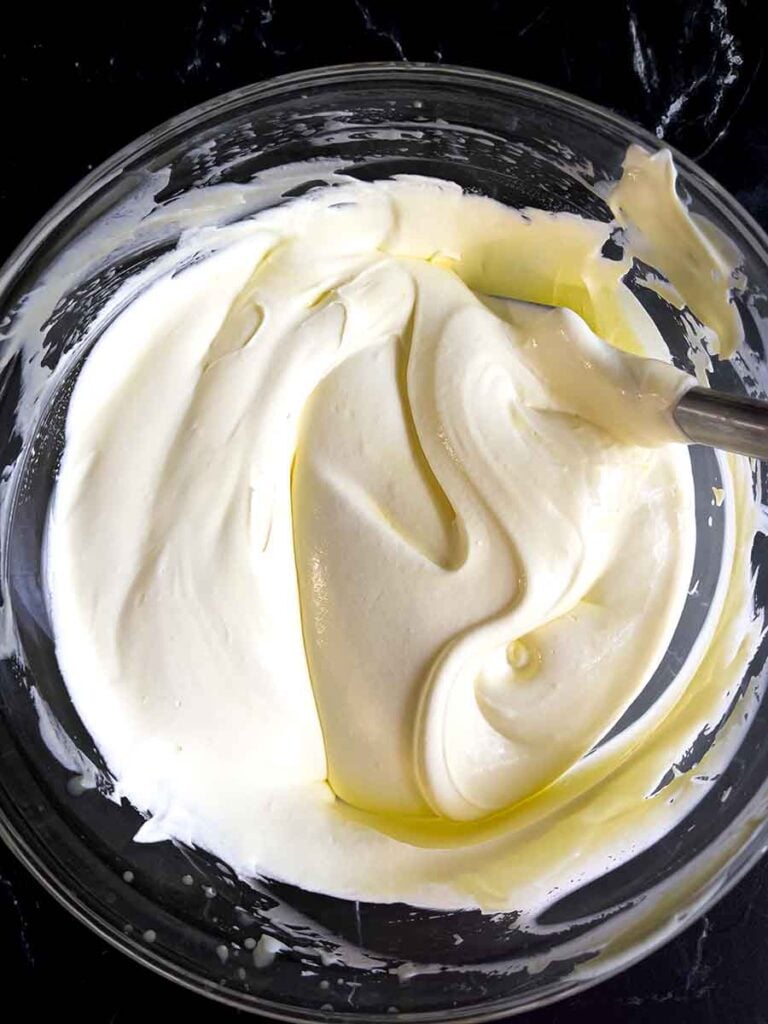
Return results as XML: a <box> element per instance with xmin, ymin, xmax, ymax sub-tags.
<box><xmin>0</xmin><ymin>0</ymin><xmax>768</xmax><ymax>1024</ymax></box>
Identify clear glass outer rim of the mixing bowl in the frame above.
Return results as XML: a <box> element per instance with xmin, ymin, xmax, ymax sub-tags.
<box><xmin>0</xmin><ymin>60</ymin><xmax>768</xmax><ymax>1024</ymax></box>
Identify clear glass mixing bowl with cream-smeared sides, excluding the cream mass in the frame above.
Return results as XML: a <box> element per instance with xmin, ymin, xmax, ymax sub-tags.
<box><xmin>0</xmin><ymin>65</ymin><xmax>768</xmax><ymax>1021</ymax></box>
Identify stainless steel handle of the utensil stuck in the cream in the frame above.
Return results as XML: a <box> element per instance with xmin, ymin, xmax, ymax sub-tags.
<box><xmin>672</xmin><ymin>387</ymin><xmax>768</xmax><ymax>459</ymax></box>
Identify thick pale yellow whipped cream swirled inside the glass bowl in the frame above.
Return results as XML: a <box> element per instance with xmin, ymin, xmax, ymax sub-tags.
<box><xmin>47</xmin><ymin>147</ymin><xmax>754</xmax><ymax>910</ymax></box>
